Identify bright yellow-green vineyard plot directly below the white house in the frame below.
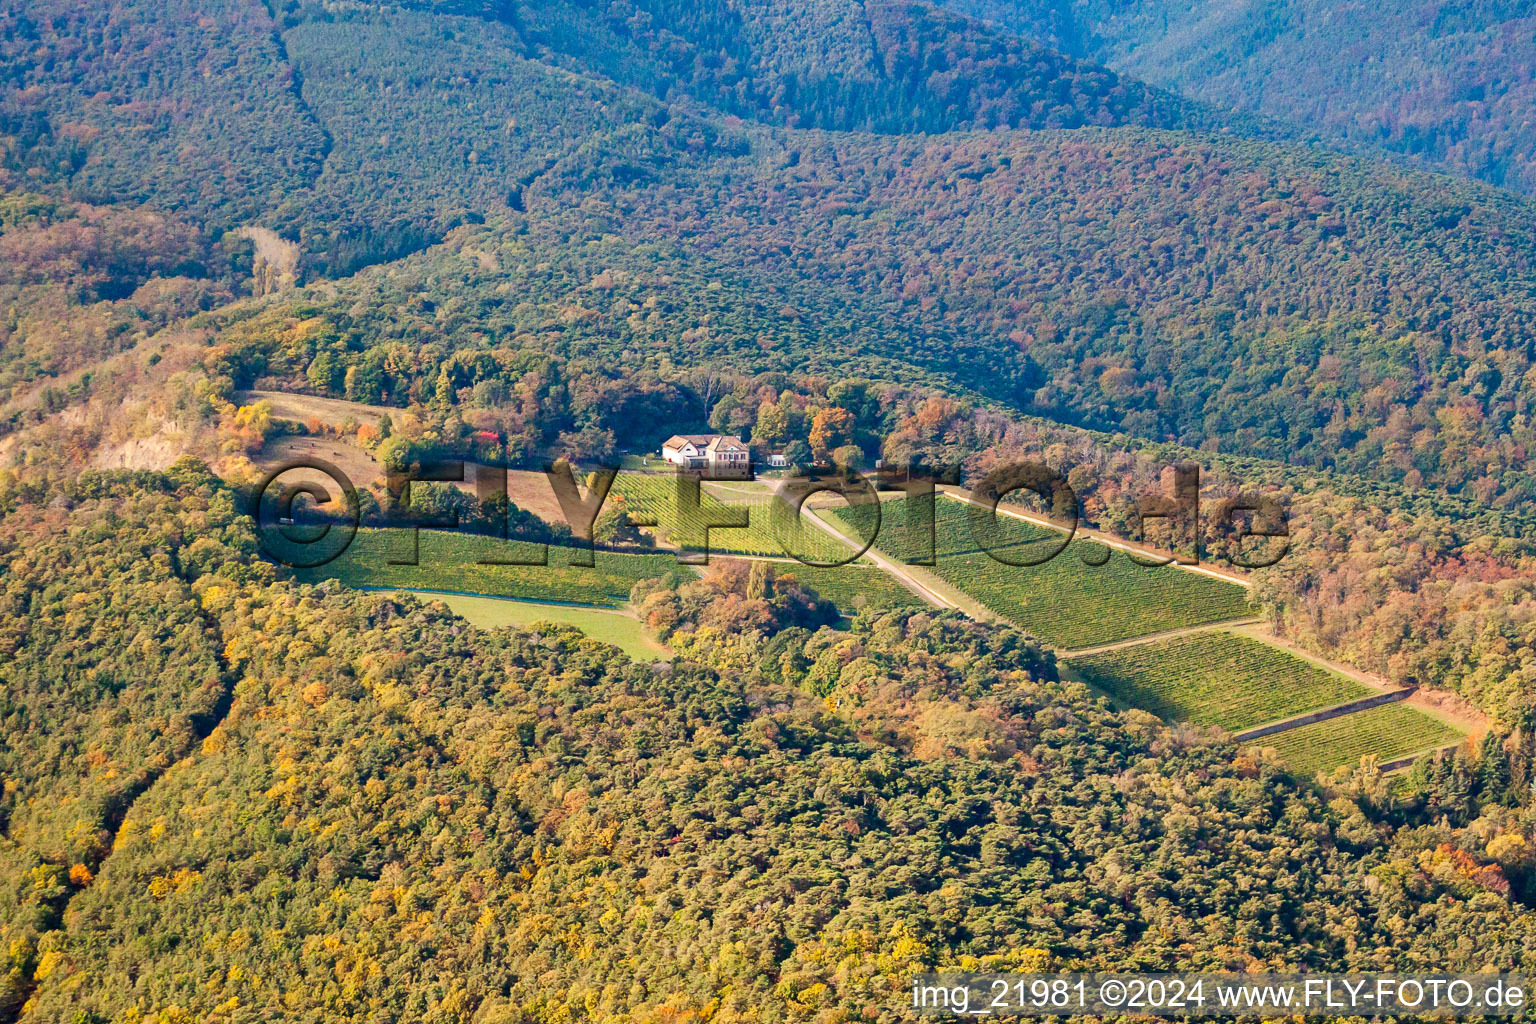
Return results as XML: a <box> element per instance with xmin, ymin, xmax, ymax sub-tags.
<box><xmin>608</xmin><ymin>473</ymin><xmax>852</xmax><ymax>562</ymax></box>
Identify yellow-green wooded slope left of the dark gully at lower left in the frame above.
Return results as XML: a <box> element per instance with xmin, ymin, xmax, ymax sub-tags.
<box><xmin>0</xmin><ymin>465</ymin><xmax>270</xmax><ymax>1019</ymax></box>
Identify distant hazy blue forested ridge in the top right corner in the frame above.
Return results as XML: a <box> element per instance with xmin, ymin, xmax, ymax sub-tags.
<box><xmin>942</xmin><ymin>0</ymin><xmax>1536</xmax><ymax>193</ymax></box>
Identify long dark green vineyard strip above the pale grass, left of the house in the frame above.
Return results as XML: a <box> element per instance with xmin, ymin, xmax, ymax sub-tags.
<box><xmin>296</xmin><ymin>530</ymin><xmax>677</xmax><ymax>608</ymax></box>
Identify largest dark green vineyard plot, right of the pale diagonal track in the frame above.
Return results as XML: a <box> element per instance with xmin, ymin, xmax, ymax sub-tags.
<box><xmin>833</xmin><ymin>497</ymin><xmax>1250</xmax><ymax>648</ymax></box>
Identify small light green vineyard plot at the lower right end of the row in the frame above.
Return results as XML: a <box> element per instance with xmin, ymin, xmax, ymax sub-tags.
<box><xmin>1253</xmin><ymin>703</ymin><xmax>1462</xmax><ymax>777</ymax></box>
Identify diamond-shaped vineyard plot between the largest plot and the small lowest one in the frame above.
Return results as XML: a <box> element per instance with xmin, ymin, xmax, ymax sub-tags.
<box><xmin>1068</xmin><ymin>633</ymin><xmax>1370</xmax><ymax>731</ymax></box>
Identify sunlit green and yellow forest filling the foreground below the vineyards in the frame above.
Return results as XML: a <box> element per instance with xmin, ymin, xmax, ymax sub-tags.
<box><xmin>9</xmin><ymin>464</ymin><xmax>1536</xmax><ymax>1021</ymax></box>
